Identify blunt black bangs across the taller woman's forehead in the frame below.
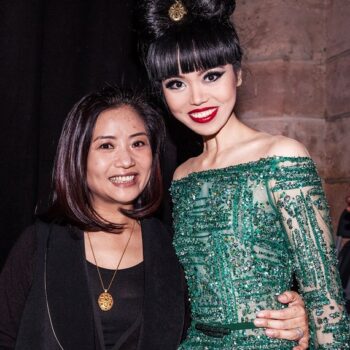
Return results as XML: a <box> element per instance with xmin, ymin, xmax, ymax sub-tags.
<box><xmin>146</xmin><ymin>21</ymin><xmax>242</xmax><ymax>82</ymax></box>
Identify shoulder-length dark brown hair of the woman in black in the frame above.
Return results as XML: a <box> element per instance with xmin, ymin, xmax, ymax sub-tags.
<box><xmin>45</xmin><ymin>86</ymin><xmax>165</xmax><ymax>232</ymax></box>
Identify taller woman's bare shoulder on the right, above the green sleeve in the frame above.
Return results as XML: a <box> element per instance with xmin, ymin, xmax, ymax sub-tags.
<box><xmin>267</xmin><ymin>135</ymin><xmax>310</xmax><ymax>157</ymax></box>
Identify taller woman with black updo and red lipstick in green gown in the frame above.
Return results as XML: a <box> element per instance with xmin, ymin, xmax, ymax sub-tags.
<box><xmin>142</xmin><ymin>0</ymin><xmax>350</xmax><ymax>350</ymax></box>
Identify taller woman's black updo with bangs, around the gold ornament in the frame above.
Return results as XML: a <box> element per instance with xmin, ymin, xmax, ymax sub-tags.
<box><xmin>139</xmin><ymin>0</ymin><xmax>242</xmax><ymax>83</ymax></box>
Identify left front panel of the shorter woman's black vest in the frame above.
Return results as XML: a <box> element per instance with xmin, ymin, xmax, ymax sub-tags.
<box><xmin>46</xmin><ymin>225</ymin><xmax>99</xmax><ymax>350</ymax></box>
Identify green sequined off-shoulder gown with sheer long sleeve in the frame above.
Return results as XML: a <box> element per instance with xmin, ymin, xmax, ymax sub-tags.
<box><xmin>171</xmin><ymin>157</ymin><xmax>350</xmax><ymax>350</ymax></box>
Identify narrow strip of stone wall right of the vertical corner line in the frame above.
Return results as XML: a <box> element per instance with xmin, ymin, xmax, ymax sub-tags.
<box><xmin>325</xmin><ymin>0</ymin><xmax>350</xmax><ymax>224</ymax></box>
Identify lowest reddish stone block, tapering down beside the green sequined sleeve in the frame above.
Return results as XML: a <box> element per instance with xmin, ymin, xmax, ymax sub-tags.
<box><xmin>323</xmin><ymin>181</ymin><xmax>350</xmax><ymax>232</ymax></box>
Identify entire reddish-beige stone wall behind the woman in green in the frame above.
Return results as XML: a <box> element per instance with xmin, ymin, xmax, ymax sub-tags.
<box><xmin>234</xmin><ymin>0</ymin><xmax>350</xmax><ymax>225</ymax></box>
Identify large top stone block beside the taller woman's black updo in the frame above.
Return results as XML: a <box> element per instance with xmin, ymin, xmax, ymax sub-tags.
<box><xmin>233</xmin><ymin>0</ymin><xmax>326</xmax><ymax>62</ymax></box>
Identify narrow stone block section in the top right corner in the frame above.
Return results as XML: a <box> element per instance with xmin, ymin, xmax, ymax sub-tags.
<box><xmin>326</xmin><ymin>0</ymin><xmax>350</xmax><ymax>58</ymax></box>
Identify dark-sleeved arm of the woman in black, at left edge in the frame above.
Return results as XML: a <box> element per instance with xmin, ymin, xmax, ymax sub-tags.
<box><xmin>0</xmin><ymin>227</ymin><xmax>36</xmax><ymax>349</ymax></box>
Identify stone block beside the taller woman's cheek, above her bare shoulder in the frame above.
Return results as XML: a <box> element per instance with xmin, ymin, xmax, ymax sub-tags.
<box><xmin>236</xmin><ymin>60</ymin><xmax>325</xmax><ymax>117</ymax></box>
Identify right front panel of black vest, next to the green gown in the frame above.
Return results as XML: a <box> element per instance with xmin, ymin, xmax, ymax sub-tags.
<box><xmin>138</xmin><ymin>219</ymin><xmax>184</xmax><ymax>350</ymax></box>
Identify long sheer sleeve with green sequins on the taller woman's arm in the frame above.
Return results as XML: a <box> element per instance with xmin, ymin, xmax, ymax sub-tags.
<box><xmin>270</xmin><ymin>158</ymin><xmax>350</xmax><ymax>350</ymax></box>
